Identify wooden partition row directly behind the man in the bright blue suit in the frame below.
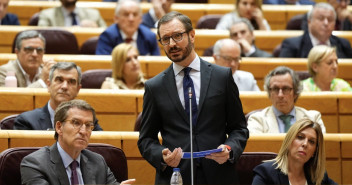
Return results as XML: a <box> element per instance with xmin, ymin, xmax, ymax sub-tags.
<box><xmin>0</xmin><ymin>26</ymin><xmax>352</xmax><ymax>56</ymax></box>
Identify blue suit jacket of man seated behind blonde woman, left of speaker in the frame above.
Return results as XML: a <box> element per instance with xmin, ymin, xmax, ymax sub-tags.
<box><xmin>95</xmin><ymin>24</ymin><xmax>160</xmax><ymax>55</ymax></box>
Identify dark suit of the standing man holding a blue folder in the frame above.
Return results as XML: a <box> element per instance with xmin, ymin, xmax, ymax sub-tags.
<box><xmin>138</xmin><ymin>59</ymin><xmax>249</xmax><ymax>184</ymax></box>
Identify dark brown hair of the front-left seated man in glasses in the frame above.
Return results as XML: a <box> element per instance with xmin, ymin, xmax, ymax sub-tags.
<box><xmin>54</xmin><ymin>99</ymin><xmax>97</xmax><ymax>140</ymax></box>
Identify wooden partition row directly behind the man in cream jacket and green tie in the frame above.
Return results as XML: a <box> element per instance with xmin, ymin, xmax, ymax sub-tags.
<box><xmin>0</xmin><ymin>87</ymin><xmax>352</xmax><ymax>133</ymax></box>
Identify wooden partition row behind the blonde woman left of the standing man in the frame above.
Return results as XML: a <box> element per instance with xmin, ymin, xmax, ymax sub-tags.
<box><xmin>0</xmin><ymin>53</ymin><xmax>352</xmax><ymax>90</ymax></box>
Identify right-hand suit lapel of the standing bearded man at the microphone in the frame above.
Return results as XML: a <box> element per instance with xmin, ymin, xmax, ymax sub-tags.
<box><xmin>198</xmin><ymin>59</ymin><xmax>212</xmax><ymax>117</ymax></box>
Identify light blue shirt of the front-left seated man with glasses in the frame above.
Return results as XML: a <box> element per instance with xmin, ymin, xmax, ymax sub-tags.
<box><xmin>57</xmin><ymin>142</ymin><xmax>84</xmax><ymax>184</ymax></box>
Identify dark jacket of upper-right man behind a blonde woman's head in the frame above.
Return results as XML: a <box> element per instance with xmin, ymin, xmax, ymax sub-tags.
<box><xmin>279</xmin><ymin>31</ymin><xmax>352</xmax><ymax>58</ymax></box>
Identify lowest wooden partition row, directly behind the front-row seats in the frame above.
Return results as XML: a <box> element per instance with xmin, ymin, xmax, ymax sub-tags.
<box><xmin>0</xmin><ymin>130</ymin><xmax>352</xmax><ymax>184</ymax></box>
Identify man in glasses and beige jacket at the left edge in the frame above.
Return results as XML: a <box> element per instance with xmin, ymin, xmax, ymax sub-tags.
<box><xmin>0</xmin><ymin>30</ymin><xmax>55</xmax><ymax>88</ymax></box>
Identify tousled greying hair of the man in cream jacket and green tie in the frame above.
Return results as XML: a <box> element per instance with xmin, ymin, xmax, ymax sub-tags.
<box><xmin>264</xmin><ymin>66</ymin><xmax>302</xmax><ymax>102</ymax></box>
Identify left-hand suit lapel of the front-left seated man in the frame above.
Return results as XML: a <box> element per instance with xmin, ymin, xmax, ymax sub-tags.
<box><xmin>49</xmin><ymin>143</ymin><xmax>70</xmax><ymax>184</ymax></box>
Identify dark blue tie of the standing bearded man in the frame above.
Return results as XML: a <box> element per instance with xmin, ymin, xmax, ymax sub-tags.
<box><xmin>183</xmin><ymin>67</ymin><xmax>198</xmax><ymax>126</ymax></box>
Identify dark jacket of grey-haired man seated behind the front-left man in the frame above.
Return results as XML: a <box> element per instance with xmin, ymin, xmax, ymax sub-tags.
<box><xmin>13</xmin><ymin>103</ymin><xmax>103</xmax><ymax>131</ymax></box>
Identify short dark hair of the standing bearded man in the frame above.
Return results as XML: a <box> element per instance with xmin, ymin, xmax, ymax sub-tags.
<box><xmin>158</xmin><ymin>11</ymin><xmax>193</xmax><ymax>38</ymax></box>
